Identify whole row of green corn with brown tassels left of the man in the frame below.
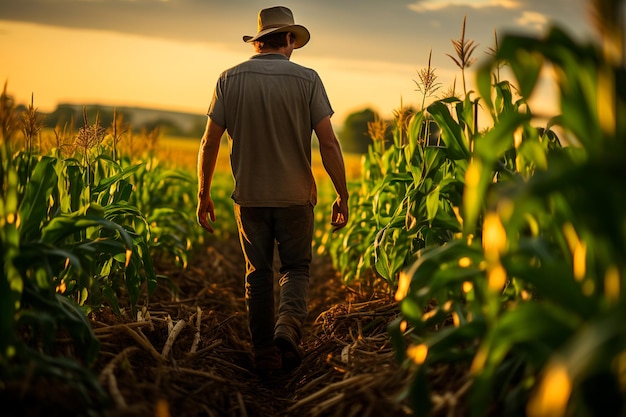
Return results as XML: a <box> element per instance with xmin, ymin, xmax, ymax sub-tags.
<box><xmin>0</xmin><ymin>95</ymin><xmax>205</xmax><ymax>410</ymax></box>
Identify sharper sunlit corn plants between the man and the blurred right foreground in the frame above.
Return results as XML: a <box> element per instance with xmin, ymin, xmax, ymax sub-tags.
<box><xmin>330</xmin><ymin>90</ymin><xmax>474</xmax><ymax>288</ymax></box>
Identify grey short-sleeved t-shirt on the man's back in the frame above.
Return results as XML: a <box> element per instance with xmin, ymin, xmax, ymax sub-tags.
<box><xmin>207</xmin><ymin>53</ymin><xmax>333</xmax><ymax>207</ymax></box>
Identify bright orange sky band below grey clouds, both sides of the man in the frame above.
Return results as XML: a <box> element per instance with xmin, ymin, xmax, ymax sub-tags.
<box><xmin>0</xmin><ymin>21</ymin><xmax>428</xmax><ymax>120</ymax></box>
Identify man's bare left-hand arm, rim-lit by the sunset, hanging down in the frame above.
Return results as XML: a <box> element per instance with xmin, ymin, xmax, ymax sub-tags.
<box><xmin>197</xmin><ymin>118</ymin><xmax>225</xmax><ymax>233</ymax></box>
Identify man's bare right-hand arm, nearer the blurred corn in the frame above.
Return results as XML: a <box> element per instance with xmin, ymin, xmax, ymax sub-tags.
<box><xmin>315</xmin><ymin>116</ymin><xmax>348</xmax><ymax>232</ymax></box>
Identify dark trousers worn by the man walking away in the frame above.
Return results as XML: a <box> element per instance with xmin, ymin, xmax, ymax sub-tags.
<box><xmin>235</xmin><ymin>204</ymin><xmax>314</xmax><ymax>350</ymax></box>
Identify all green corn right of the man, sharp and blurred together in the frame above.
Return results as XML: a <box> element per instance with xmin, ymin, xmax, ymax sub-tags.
<box><xmin>330</xmin><ymin>2</ymin><xmax>626</xmax><ymax>416</ymax></box>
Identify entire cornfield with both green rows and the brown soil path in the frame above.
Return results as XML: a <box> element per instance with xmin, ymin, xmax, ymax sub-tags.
<box><xmin>0</xmin><ymin>8</ymin><xmax>626</xmax><ymax>417</ymax></box>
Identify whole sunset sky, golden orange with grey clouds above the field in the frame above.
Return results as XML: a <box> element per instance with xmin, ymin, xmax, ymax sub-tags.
<box><xmin>0</xmin><ymin>0</ymin><xmax>594</xmax><ymax>123</ymax></box>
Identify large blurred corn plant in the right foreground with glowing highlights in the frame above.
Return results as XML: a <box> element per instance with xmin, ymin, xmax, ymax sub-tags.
<box><xmin>391</xmin><ymin>14</ymin><xmax>626</xmax><ymax>416</ymax></box>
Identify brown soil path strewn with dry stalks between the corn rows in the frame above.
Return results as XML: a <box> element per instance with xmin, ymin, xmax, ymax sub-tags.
<box><xmin>0</xmin><ymin>234</ymin><xmax>463</xmax><ymax>417</ymax></box>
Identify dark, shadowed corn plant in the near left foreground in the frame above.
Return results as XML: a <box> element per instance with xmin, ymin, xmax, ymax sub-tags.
<box><xmin>0</xmin><ymin>112</ymin><xmax>109</xmax><ymax>404</ymax></box>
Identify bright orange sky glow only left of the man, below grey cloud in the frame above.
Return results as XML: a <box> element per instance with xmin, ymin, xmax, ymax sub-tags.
<box><xmin>0</xmin><ymin>22</ymin><xmax>241</xmax><ymax>111</ymax></box>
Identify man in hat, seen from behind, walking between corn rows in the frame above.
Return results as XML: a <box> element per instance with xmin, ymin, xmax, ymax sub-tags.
<box><xmin>197</xmin><ymin>7</ymin><xmax>348</xmax><ymax>375</ymax></box>
